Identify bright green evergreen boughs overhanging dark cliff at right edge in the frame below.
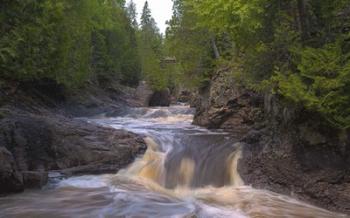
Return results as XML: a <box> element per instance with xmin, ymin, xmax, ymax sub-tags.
<box><xmin>273</xmin><ymin>43</ymin><xmax>350</xmax><ymax>128</ymax></box>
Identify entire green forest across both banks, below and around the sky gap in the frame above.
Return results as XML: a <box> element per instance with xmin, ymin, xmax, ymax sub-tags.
<box><xmin>0</xmin><ymin>0</ymin><xmax>350</xmax><ymax>129</ymax></box>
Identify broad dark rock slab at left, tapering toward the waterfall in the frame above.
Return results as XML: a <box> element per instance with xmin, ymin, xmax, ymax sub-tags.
<box><xmin>0</xmin><ymin>112</ymin><xmax>146</xmax><ymax>194</ymax></box>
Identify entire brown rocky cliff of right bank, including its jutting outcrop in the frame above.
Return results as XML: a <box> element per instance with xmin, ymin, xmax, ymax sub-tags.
<box><xmin>194</xmin><ymin>71</ymin><xmax>350</xmax><ymax>213</ymax></box>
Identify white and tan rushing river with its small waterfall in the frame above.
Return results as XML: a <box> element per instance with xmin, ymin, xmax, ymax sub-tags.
<box><xmin>0</xmin><ymin>106</ymin><xmax>345</xmax><ymax>218</ymax></box>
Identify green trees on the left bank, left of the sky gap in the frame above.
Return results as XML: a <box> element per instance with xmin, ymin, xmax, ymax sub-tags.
<box><xmin>0</xmin><ymin>0</ymin><xmax>140</xmax><ymax>87</ymax></box>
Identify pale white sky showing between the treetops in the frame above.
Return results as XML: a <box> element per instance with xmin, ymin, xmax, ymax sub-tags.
<box><xmin>128</xmin><ymin>0</ymin><xmax>173</xmax><ymax>33</ymax></box>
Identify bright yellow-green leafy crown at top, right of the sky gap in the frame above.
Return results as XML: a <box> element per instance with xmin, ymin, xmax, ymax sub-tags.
<box><xmin>185</xmin><ymin>0</ymin><xmax>271</xmax><ymax>43</ymax></box>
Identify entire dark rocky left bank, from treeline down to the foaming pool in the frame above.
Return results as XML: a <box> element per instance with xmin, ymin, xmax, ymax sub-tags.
<box><xmin>0</xmin><ymin>81</ymin><xmax>146</xmax><ymax>195</ymax></box>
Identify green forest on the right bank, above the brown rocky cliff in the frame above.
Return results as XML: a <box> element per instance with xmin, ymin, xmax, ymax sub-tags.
<box><xmin>166</xmin><ymin>0</ymin><xmax>350</xmax><ymax>129</ymax></box>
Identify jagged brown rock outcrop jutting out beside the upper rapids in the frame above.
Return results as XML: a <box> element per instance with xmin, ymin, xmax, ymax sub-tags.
<box><xmin>192</xmin><ymin>70</ymin><xmax>263</xmax><ymax>137</ymax></box>
